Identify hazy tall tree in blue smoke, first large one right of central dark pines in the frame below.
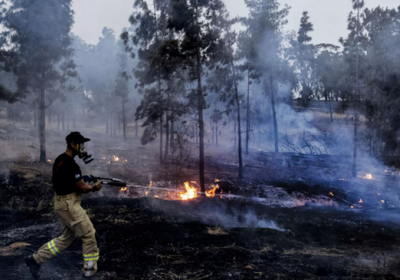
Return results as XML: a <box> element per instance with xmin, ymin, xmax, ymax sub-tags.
<box><xmin>239</xmin><ymin>0</ymin><xmax>292</xmax><ymax>153</ymax></box>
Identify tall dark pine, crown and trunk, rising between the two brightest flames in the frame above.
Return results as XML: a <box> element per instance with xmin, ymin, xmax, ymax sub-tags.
<box><xmin>168</xmin><ymin>0</ymin><xmax>231</xmax><ymax>192</ymax></box>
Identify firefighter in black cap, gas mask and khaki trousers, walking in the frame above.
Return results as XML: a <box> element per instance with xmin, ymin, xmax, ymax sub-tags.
<box><xmin>25</xmin><ymin>131</ymin><xmax>102</xmax><ymax>279</ymax></box>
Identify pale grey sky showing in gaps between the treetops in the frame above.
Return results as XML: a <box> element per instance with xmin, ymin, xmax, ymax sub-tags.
<box><xmin>72</xmin><ymin>0</ymin><xmax>400</xmax><ymax>45</ymax></box>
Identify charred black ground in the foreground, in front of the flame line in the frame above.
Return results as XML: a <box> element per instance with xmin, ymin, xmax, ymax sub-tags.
<box><xmin>0</xmin><ymin>195</ymin><xmax>400</xmax><ymax>280</ymax></box>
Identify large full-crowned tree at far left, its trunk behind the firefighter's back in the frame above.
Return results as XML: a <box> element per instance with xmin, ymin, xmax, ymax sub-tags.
<box><xmin>1</xmin><ymin>0</ymin><xmax>76</xmax><ymax>162</ymax></box>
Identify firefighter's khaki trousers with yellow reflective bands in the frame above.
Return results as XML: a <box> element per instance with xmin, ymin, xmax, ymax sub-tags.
<box><xmin>33</xmin><ymin>193</ymin><xmax>99</xmax><ymax>277</ymax></box>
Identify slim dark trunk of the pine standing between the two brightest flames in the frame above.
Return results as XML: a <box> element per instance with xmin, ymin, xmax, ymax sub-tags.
<box><xmin>196</xmin><ymin>0</ymin><xmax>206</xmax><ymax>193</ymax></box>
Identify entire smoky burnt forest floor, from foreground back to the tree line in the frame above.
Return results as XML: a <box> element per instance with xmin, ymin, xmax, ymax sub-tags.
<box><xmin>0</xmin><ymin>122</ymin><xmax>400</xmax><ymax>280</ymax></box>
